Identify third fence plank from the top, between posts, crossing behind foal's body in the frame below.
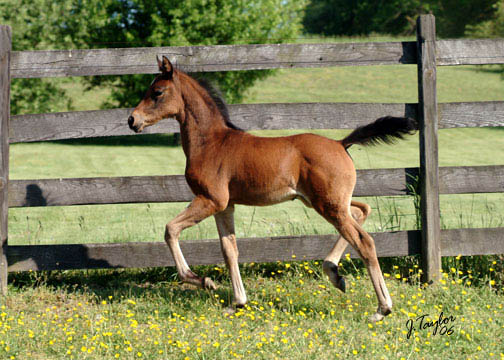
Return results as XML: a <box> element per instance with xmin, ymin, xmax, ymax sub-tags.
<box><xmin>9</xmin><ymin>169</ymin><xmax>418</xmax><ymax>207</ymax></box>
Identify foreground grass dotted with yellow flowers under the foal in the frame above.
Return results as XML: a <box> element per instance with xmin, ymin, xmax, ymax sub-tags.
<box><xmin>0</xmin><ymin>260</ymin><xmax>504</xmax><ymax>359</ymax></box>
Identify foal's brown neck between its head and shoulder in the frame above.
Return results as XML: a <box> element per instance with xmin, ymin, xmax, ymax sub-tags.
<box><xmin>175</xmin><ymin>73</ymin><xmax>227</xmax><ymax>160</ymax></box>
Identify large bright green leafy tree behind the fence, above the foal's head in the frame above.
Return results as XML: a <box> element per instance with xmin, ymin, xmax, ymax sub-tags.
<box><xmin>63</xmin><ymin>0</ymin><xmax>305</xmax><ymax>106</ymax></box>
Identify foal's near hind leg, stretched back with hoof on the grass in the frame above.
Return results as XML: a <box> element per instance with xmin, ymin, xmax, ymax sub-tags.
<box><xmin>316</xmin><ymin>203</ymin><xmax>392</xmax><ymax>322</ymax></box>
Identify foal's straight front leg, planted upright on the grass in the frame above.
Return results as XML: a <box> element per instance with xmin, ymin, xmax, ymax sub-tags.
<box><xmin>214</xmin><ymin>206</ymin><xmax>247</xmax><ymax>307</ymax></box>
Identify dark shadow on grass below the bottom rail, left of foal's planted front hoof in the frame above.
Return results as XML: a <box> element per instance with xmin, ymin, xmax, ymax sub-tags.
<box><xmin>9</xmin><ymin>266</ymin><xmax>233</xmax><ymax>310</ymax></box>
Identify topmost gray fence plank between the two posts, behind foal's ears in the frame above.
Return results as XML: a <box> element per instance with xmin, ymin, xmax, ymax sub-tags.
<box><xmin>12</xmin><ymin>42</ymin><xmax>416</xmax><ymax>78</ymax></box>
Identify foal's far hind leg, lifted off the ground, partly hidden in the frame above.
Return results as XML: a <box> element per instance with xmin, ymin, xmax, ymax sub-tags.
<box><xmin>322</xmin><ymin>201</ymin><xmax>371</xmax><ymax>292</ymax></box>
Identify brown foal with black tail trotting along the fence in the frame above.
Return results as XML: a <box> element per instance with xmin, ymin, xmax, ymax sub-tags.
<box><xmin>128</xmin><ymin>56</ymin><xmax>417</xmax><ymax>321</ymax></box>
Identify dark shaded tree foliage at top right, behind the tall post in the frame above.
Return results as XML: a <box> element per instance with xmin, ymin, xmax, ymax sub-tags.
<box><xmin>303</xmin><ymin>0</ymin><xmax>501</xmax><ymax>37</ymax></box>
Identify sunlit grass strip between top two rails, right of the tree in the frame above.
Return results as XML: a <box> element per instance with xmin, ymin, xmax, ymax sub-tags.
<box><xmin>242</xmin><ymin>65</ymin><xmax>504</xmax><ymax>103</ymax></box>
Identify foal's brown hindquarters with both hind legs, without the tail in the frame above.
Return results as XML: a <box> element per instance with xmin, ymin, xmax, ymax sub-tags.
<box><xmin>290</xmin><ymin>135</ymin><xmax>392</xmax><ymax>322</ymax></box>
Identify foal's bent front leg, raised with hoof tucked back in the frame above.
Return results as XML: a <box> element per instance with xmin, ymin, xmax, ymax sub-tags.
<box><xmin>165</xmin><ymin>196</ymin><xmax>220</xmax><ymax>289</ymax></box>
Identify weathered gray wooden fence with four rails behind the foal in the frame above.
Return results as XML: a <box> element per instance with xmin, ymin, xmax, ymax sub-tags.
<box><xmin>0</xmin><ymin>15</ymin><xmax>504</xmax><ymax>293</ymax></box>
